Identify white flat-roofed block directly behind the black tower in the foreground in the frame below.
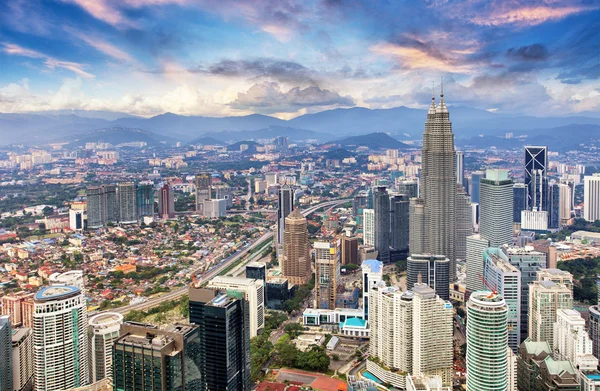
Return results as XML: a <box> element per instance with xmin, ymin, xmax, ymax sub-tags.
<box><xmin>206</xmin><ymin>276</ymin><xmax>266</xmax><ymax>338</ymax></box>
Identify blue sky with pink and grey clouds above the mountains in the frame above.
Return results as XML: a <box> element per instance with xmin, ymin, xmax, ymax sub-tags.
<box><xmin>0</xmin><ymin>0</ymin><xmax>600</xmax><ymax>119</ymax></box>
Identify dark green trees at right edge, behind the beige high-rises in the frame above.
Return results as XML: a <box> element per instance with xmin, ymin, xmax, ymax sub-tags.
<box><xmin>558</xmin><ymin>258</ymin><xmax>600</xmax><ymax>303</ymax></box>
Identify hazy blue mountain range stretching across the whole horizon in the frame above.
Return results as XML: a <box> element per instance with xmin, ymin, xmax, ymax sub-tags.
<box><xmin>0</xmin><ymin>106</ymin><xmax>600</xmax><ymax>145</ymax></box>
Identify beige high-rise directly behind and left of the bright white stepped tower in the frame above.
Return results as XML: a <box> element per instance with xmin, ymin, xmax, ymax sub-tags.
<box><xmin>529</xmin><ymin>280</ymin><xmax>573</xmax><ymax>347</ymax></box>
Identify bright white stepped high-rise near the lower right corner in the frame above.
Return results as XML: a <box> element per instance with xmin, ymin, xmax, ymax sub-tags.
<box><xmin>554</xmin><ymin>309</ymin><xmax>598</xmax><ymax>371</ymax></box>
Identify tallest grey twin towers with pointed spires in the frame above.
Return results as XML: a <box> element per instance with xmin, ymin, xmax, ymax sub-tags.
<box><xmin>410</xmin><ymin>89</ymin><xmax>457</xmax><ymax>281</ymax></box>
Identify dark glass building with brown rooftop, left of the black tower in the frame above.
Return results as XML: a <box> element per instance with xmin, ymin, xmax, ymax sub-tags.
<box><xmin>113</xmin><ymin>322</ymin><xmax>204</xmax><ymax>391</ymax></box>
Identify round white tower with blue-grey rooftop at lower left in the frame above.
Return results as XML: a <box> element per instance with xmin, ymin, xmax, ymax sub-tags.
<box><xmin>33</xmin><ymin>285</ymin><xmax>89</xmax><ymax>391</ymax></box>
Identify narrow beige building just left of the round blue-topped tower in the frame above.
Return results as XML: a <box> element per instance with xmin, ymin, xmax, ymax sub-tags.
<box><xmin>11</xmin><ymin>327</ymin><xmax>33</xmax><ymax>391</ymax></box>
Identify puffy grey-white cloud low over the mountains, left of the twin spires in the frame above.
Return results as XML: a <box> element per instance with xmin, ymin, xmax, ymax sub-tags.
<box><xmin>229</xmin><ymin>82</ymin><xmax>355</xmax><ymax>114</ymax></box>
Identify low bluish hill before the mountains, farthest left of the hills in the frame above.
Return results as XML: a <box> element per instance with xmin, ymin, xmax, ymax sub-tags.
<box><xmin>71</xmin><ymin>126</ymin><xmax>173</xmax><ymax>146</ymax></box>
